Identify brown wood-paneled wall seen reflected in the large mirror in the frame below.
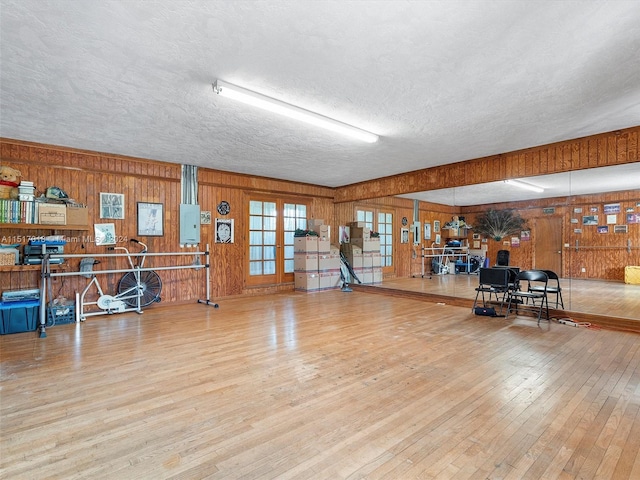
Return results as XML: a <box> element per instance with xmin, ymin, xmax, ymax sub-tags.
<box><xmin>335</xmin><ymin>190</ymin><xmax>640</xmax><ymax>281</ymax></box>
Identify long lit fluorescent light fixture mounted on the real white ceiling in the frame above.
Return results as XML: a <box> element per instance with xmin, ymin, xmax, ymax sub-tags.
<box><xmin>213</xmin><ymin>80</ymin><xmax>378</xmax><ymax>143</ymax></box>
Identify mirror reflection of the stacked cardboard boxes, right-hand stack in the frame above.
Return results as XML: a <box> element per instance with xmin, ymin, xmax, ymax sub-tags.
<box><xmin>340</xmin><ymin>222</ymin><xmax>382</xmax><ymax>284</ymax></box>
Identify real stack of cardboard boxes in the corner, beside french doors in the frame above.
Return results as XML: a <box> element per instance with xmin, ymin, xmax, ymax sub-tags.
<box><xmin>293</xmin><ymin>219</ymin><xmax>340</xmax><ymax>292</ymax></box>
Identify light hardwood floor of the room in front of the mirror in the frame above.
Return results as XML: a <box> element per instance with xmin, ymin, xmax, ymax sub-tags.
<box><xmin>0</xmin><ymin>290</ymin><xmax>640</xmax><ymax>480</ymax></box>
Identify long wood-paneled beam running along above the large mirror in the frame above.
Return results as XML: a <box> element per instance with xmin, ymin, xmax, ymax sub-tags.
<box><xmin>335</xmin><ymin>126</ymin><xmax>640</xmax><ymax>202</ymax></box>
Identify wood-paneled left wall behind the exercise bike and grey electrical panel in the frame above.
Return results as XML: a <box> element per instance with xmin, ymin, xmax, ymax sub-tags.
<box><xmin>0</xmin><ymin>139</ymin><xmax>334</xmax><ymax>303</ymax></box>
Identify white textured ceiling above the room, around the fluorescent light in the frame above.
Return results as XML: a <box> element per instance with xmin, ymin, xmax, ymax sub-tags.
<box><xmin>0</xmin><ymin>0</ymin><xmax>640</xmax><ymax>203</ymax></box>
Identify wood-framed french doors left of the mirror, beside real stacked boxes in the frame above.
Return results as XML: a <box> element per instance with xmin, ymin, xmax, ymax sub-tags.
<box><xmin>247</xmin><ymin>197</ymin><xmax>308</xmax><ymax>286</ymax></box>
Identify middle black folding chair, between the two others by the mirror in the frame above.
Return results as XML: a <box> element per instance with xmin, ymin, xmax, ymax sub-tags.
<box><xmin>505</xmin><ymin>270</ymin><xmax>549</xmax><ymax>325</ymax></box>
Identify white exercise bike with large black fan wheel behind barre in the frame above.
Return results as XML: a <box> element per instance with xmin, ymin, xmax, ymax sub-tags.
<box><xmin>79</xmin><ymin>238</ymin><xmax>162</xmax><ymax>321</ymax></box>
